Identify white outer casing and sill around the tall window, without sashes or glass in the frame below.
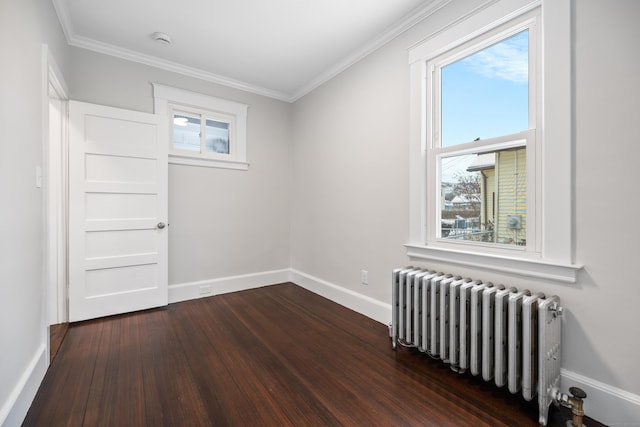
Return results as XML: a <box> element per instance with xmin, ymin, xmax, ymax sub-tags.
<box><xmin>405</xmin><ymin>0</ymin><xmax>581</xmax><ymax>283</ymax></box>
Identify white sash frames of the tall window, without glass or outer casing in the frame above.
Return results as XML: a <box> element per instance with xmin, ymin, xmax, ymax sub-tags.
<box><xmin>425</xmin><ymin>9</ymin><xmax>541</xmax><ymax>257</ymax></box>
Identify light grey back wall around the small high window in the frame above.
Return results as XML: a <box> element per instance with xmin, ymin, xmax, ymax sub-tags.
<box><xmin>69</xmin><ymin>48</ymin><xmax>291</xmax><ymax>301</ymax></box>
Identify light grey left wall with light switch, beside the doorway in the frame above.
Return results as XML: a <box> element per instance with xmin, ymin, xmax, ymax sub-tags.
<box><xmin>0</xmin><ymin>0</ymin><xmax>68</xmax><ymax>426</ymax></box>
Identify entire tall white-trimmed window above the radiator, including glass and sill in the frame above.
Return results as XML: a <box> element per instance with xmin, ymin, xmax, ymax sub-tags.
<box><xmin>405</xmin><ymin>0</ymin><xmax>580</xmax><ymax>282</ymax></box>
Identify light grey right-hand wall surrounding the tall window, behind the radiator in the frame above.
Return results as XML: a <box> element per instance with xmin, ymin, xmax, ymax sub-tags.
<box><xmin>292</xmin><ymin>0</ymin><xmax>640</xmax><ymax>425</ymax></box>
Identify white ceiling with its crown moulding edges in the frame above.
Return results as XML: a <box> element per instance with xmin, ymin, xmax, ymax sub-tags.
<box><xmin>52</xmin><ymin>0</ymin><xmax>447</xmax><ymax>101</ymax></box>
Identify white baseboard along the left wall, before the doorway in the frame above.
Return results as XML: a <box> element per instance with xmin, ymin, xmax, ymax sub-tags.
<box><xmin>0</xmin><ymin>344</ymin><xmax>48</xmax><ymax>427</ymax></box>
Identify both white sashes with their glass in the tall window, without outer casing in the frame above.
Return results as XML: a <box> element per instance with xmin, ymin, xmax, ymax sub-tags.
<box><xmin>427</xmin><ymin>15</ymin><xmax>538</xmax><ymax>252</ymax></box>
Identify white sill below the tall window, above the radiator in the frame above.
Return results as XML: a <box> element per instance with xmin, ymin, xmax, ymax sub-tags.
<box><xmin>404</xmin><ymin>244</ymin><xmax>582</xmax><ymax>283</ymax></box>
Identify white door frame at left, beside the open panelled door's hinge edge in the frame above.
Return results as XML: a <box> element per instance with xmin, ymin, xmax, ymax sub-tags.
<box><xmin>42</xmin><ymin>44</ymin><xmax>69</xmax><ymax>336</ymax></box>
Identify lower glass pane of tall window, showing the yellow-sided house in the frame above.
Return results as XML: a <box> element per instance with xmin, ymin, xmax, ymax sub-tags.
<box><xmin>440</xmin><ymin>148</ymin><xmax>527</xmax><ymax>246</ymax></box>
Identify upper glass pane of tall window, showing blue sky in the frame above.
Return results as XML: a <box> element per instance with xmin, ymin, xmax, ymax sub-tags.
<box><xmin>441</xmin><ymin>30</ymin><xmax>529</xmax><ymax>147</ymax></box>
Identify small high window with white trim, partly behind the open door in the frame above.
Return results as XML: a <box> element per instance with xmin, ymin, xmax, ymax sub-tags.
<box><xmin>153</xmin><ymin>84</ymin><xmax>249</xmax><ymax>170</ymax></box>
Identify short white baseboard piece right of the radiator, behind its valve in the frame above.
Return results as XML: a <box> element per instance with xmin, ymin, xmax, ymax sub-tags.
<box><xmin>560</xmin><ymin>369</ymin><xmax>640</xmax><ymax>427</ymax></box>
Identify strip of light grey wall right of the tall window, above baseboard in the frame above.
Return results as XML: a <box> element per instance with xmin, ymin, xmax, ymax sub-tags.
<box><xmin>566</xmin><ymin>0</ymin><xmax>640</xmax><ymax>425</ymax></box>
